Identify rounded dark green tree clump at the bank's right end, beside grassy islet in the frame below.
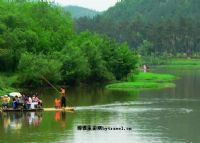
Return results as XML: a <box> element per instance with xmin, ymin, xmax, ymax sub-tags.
<box><xmin>59</xmin><ymin>32</ymin><xmax>138</xmax><ymax>82</ymax></box>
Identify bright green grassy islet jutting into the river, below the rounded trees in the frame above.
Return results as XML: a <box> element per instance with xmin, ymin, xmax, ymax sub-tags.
<box><xmin>106</xmin><ymin>73</ymin><xmax>176</xmax><ymax>90</ymax></box>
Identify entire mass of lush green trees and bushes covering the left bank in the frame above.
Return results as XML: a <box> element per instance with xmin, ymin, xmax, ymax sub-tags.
<box><xmin>0</xmin><ymin>0</ymin><xmax>138</xmax><ymax>87</ymax></box>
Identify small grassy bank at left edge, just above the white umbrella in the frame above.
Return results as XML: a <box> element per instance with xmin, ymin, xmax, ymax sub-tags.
<box><xmin>0</xmin><ymin>73</ymin><xmax>17</xmax><ymax>96</ymax></box>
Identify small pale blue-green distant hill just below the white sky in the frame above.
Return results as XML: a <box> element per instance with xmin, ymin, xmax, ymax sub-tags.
<box><xmin>64</xmin><ymin>6</ymin><xmax>101</xmax><ymax>18</ymax></box>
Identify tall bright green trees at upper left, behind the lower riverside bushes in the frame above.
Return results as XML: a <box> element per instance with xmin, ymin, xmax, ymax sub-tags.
<box><xmin>0</xmin><ymin>1</ymin><xmax>73</xmax><ymax>71</ymax></box>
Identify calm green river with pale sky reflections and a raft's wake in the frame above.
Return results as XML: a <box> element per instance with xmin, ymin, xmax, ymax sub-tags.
<box><xmin>0</xmin><ymin>70</ymin><xmax>200</xmax><ymax>143</ymax></box>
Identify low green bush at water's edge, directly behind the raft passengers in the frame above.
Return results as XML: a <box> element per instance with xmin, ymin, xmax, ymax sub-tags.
<box><xmin>18</xmin><ymin>53</ymin><xmax>61</xmax><ymax>86</ymax></box>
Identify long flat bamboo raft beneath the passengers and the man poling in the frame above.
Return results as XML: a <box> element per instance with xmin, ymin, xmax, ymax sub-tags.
<box><xmin>0</xmin><ymin>107</ymin><xmax>74</xmax><ymax>112</ymax></box>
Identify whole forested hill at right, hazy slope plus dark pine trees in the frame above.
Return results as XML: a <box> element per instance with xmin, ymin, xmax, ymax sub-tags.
<box><xmin>76</xmin><ymin>0</ymin><xmax>200</xmax><ymax>56</ymax></box>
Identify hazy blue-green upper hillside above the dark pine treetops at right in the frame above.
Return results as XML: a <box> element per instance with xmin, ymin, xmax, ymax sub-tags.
<box><xmin>103</xmin><ymin>0</ymin><xmax>200</xmax><ymax>22</ymax></box>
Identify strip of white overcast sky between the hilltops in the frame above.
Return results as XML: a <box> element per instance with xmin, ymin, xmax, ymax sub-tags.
<box><xmin>55</xmin><ymin>0</ymin><xmax>119</xmax><ymax>11</ymax></box>
